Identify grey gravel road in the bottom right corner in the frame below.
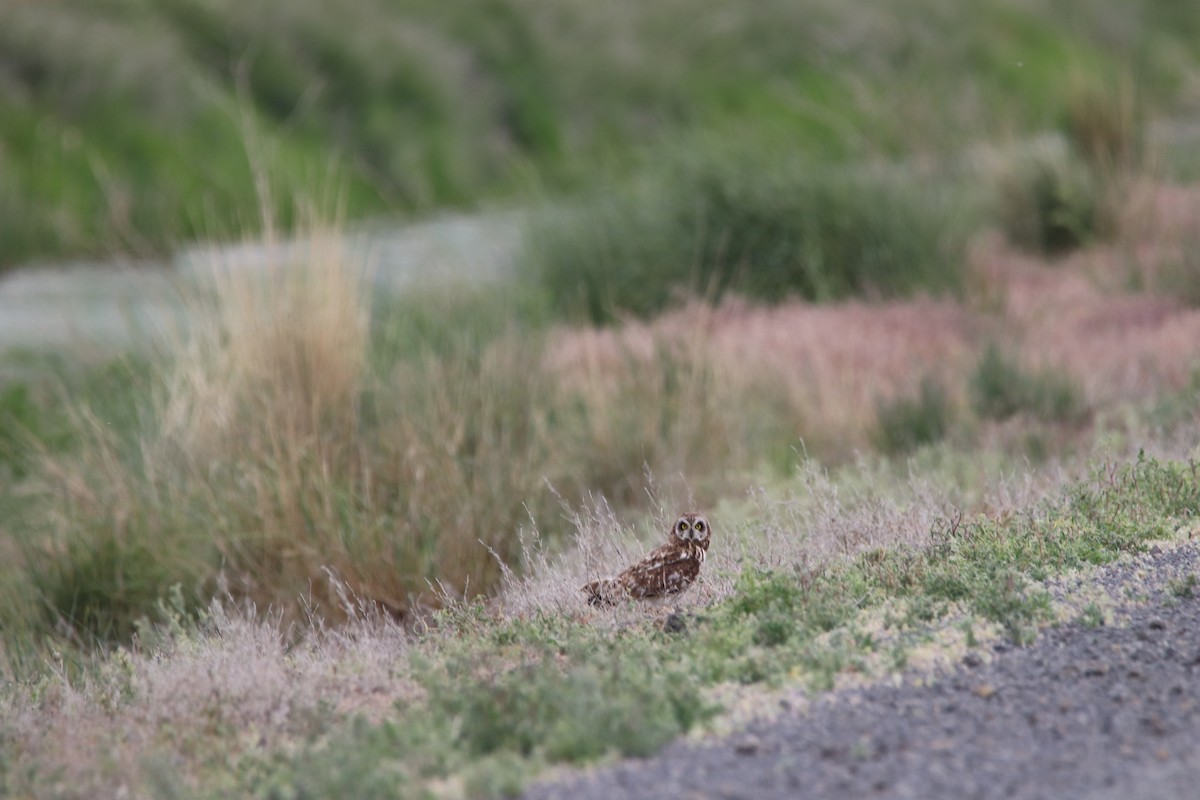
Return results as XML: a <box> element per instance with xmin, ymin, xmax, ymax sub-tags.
<box><xmin>526</xmin><ymin>543</ymin><xmax>1200</xmax><ymax>800</ymax></box>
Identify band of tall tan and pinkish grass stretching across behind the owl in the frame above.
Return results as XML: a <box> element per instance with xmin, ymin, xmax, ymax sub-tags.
<box><xmin>16</xmin><ymin>179</ymin><xmax>1200</xmax><ymax>640</ymax></box>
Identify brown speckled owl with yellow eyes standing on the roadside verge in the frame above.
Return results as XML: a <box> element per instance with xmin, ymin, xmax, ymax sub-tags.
<box><xmin>580</xmin><ymin>512</ymin><xmax>712</xmax><ymax>606</ymax></box>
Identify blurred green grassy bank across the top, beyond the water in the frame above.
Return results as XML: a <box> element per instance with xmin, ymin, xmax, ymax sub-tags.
<box><xmin>0</xmin><ymin>0</ymin><xmax>1200</xmax><ymax>268</ymax></box>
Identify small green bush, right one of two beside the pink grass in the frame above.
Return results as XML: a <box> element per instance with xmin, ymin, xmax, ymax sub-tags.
<box><xmin>970</xmin><ymin>344</ymin><xmax>1084</xmax><ymax>422</ymax></box>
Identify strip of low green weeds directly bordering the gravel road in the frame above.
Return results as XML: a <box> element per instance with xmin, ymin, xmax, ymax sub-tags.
<box><xmin>174</xmin><ymin>458</ymin><xmax>1200</xmax><ymax>798</ymax></box>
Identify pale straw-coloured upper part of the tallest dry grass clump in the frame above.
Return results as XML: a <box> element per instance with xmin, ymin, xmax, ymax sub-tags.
<box><xmin>162</xmin><ymin>231</ymin><xmax>370</xmax><ymax>460</ymax></box>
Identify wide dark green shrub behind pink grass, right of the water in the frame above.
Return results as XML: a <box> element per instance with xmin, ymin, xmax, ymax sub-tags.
<box><xmin>524</xmin><ymin>149</ymin><xmax>960</xmax><ymax>321</ymax></box>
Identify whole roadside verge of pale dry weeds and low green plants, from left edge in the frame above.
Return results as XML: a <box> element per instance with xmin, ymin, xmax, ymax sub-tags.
<box><xmin>4</xmin><ymin>457</ymin><xmax>1200</xmax><ymax>798</ymax></box>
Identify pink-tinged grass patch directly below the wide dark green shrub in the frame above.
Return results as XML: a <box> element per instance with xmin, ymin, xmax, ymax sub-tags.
<box><xmin>548</xmin><ymin>293</ymin><xmax>977</xmax><ymax>458</ymax></box>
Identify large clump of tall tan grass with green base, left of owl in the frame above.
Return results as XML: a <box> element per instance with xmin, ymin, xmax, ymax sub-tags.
<box><xmin>21</xmin><ymin>225</ymin><xmax>553</xmax><ymax>639</ymax></box>
